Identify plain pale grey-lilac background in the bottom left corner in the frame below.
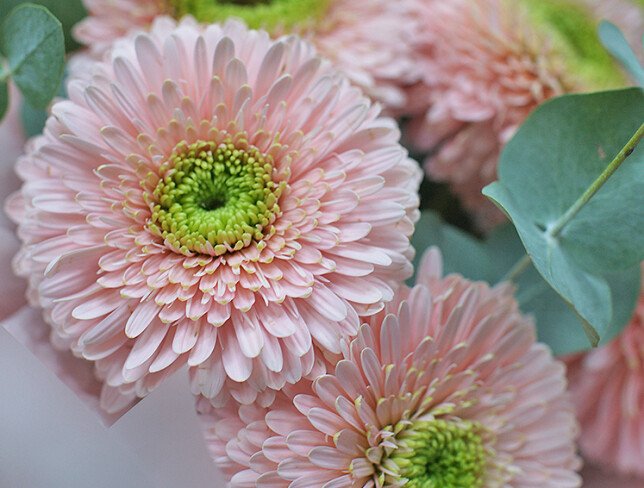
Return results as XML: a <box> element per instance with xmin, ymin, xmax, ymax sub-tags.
<box><xmin>0</xmin><ymin>327</ymin><xmax>225</xmax><ymax>488</ymax></box>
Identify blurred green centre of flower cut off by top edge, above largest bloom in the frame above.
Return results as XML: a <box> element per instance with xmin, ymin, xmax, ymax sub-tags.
<box><xmin>169</xmin><ymin>0</ymin><xmax>329</xmax><ymax>31</ymax></box>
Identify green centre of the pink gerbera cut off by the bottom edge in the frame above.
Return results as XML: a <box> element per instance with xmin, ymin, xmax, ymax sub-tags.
<box><xmin>391</xmin><ymin>420</ymin><xmax>486</xmax><ymax>488</ymax></box>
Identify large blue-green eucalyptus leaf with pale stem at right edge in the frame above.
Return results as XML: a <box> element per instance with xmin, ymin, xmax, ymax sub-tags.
<box><xmin>483</xmin><ymin>88</ymin><xmax>644</xmax><ymax>344</ymax></box>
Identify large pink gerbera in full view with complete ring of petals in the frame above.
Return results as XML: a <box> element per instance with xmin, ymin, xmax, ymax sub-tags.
<box><xmin>12</xmin><ymin>18</ymin><xmax>420</xmax><ymax>407</ymax></box>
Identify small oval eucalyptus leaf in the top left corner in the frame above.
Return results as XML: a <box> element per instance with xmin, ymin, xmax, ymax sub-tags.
<box><xmin>0</xmin><ymin>4</ymin><xmax>65</xmax><ymax>108</ymax></box>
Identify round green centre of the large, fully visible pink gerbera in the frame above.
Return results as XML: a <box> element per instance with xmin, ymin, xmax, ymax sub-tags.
<box><xmin>148</xmin><ymin>140</ymin><xmax>286</xmax><ymax>256</ymax></box>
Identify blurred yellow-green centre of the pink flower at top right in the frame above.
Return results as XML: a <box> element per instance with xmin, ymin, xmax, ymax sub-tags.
<box><xmin>522</xmin><ymin>0</ymin><xmax>625</xmax><ymax>89</ymax></box>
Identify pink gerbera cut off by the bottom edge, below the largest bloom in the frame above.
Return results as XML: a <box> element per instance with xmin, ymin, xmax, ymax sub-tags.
<box><xmin>198</xmin><ymin>250</ymin><xmax>580</xmax><ymax>488</ymax></box>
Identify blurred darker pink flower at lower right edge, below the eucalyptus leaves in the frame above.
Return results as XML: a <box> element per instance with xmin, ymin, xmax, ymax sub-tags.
<box><xmin>568</xmin><ymin>274</ymin><xmax>644</xmax><ymax>477</ymax></box>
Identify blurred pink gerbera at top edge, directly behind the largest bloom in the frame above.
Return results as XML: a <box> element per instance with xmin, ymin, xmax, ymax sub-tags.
<box><xmin>74</xmin><ymin>0</ymin><xmax>419</xmax><ymax>110</ymax></box>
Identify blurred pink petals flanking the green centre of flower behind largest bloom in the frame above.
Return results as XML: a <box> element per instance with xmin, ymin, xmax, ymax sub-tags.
<box><xmin>74</xmin><ymin>0</ymin><xmax>423</xmax><ymax>110</ymax></box>
